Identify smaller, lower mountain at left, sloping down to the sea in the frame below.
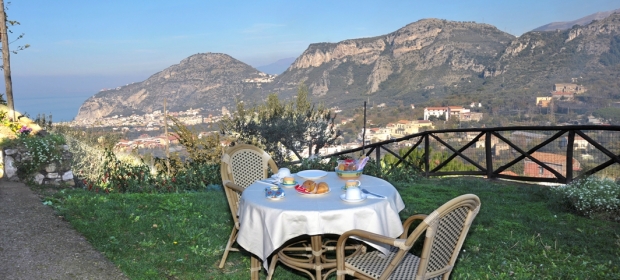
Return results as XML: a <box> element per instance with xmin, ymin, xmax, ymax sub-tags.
<box><xmin>75</xmin><ymin>53</ymin><xmax>265</xmax><ymax>120</ymax></box>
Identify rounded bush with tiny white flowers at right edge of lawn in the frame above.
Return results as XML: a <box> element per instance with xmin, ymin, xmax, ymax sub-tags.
<box><xmin>553</xmin><ymin>177</ymin><xmax>620</xmax><ymax>219</ymax></box>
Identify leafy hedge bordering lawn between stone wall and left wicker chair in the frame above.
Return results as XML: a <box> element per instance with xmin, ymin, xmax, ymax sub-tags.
<box><xmin>65</xmin><ymin>120</ymin><xmax>221</xmax><ymax>193</ymax></box>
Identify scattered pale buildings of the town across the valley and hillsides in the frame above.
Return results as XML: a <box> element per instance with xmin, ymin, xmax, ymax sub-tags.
<box><xmin>65</xmin><ymin>80</ymin><xmax>602</xmax><ymax>173</ymax></box>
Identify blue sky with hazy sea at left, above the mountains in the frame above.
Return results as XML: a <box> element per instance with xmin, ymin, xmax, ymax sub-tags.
<box><xmin>0</xmin><ymin>0</ymin><xmax>620</xmax><ymax>121</ymax></box>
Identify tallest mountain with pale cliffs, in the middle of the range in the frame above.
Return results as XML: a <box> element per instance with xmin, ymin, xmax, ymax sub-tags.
<box><xmin>269</xmin><ymin>19</ymin><xmax>515</xmax><ymax>108</ymax></box>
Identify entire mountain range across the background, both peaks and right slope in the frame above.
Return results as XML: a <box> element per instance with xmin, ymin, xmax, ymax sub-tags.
<box><xmin>76</xmin><ymin>13</ymin><xmax>620</xmax><ymax>120</ymax></box>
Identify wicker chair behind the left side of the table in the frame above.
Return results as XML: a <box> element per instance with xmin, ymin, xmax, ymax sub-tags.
<box><xmin>220</xmin><ymin>144</ymin><xmax>278</xmax><ymax>268</ymax></box>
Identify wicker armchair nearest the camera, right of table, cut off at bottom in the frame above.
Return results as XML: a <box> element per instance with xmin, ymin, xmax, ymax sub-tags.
<box><xmin>336</xmin><ymin>194</ymin><xmax>480</xmax><ymax>280</ymax></box>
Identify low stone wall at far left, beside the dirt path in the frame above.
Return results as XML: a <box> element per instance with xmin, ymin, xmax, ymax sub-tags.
<box><xmin>0</xmin><ymin>145</ymin><xmax>75</xmax><ymax>186</ymax></box>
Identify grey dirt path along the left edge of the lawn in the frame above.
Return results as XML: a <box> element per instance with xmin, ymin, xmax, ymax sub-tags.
<box><xmin>0</xmin><ymin>180</ymin><xmax>127</xmax><ymax>279</ymax></box>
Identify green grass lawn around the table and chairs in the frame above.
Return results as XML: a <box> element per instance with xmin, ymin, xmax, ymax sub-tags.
<box><xmin>46</xmin><ymin>178</ymin><xmax>620</xmax><ymax>279</ymax></box>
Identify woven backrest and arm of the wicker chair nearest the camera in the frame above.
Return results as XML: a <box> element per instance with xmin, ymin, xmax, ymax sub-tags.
<box><xmin>384</xmin><ymin>194</ymin><xmax>480</xmax><ymax>280</ymax></box>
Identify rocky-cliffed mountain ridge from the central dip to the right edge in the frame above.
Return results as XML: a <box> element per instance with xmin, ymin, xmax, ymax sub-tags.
<box><xmin>266</xmin><ymin>13</ymin><xmax>620</xmax><ymax>110</ymax></box>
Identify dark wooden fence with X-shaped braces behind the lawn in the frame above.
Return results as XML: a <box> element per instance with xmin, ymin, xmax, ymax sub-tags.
<box><xmin>324</xmin><ymin>125</ymin><xmax>620</xmax><ymax>184</ymax></box>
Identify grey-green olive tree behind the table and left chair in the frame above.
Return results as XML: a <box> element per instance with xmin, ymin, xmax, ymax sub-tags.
<box><xmin>221</xmin><ymin>83</ymin><xmax>340</xmax><ymax>161</ymax></box>
